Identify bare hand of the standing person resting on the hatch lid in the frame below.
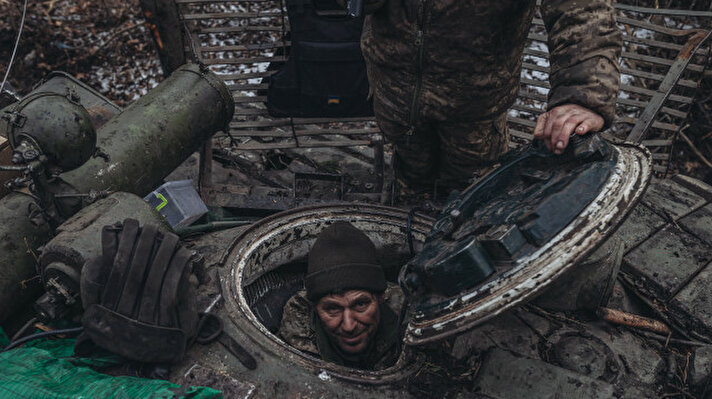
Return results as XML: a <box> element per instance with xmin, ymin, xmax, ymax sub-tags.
<box><xmin>534</xmin><ymin>104</ymin><xmax>603</xmax><ymax>154</ymax></box>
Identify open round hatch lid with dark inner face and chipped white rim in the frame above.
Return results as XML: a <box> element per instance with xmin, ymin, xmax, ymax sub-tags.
<box><xmin>399</xmin><ymin>135</ymin><xmax>651</xmax><ymax>345</ymax></box>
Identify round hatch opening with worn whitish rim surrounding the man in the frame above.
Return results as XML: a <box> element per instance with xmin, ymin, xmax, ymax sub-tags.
<box><xmin>226</xmin><ymin>205</ymin><xmax>432</xmax><ymax>383</ymax></box>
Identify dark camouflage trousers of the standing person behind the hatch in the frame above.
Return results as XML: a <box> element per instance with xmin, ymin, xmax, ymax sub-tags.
<box><xmin>376</xmin><ymin>108</ymin><xmax>509</xmax><ymax>192</ymax></box>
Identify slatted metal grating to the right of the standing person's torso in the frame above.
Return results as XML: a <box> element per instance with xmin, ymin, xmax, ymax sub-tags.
<box><xmin>508</xmin><ymin>3</ymin><xmax>712</xmax><ymax>176</ymax></box>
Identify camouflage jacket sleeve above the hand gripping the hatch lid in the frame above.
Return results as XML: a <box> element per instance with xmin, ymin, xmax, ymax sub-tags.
<box><xmin>541</xmin><ymin>0</ymin><xmax>622</xmax><ymax>128</ymax></box>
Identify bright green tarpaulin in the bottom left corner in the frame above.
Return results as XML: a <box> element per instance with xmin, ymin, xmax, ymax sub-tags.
<box><xmin>0</xmin><ymin>328</ymin><xmax>222</xmax><ymax>399</ymax></box>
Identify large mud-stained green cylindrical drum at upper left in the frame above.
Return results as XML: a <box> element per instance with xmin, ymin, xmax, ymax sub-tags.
<box><xmin>60</xmin><ymin>64</ymin><xmax>235</xmax><ymax>197</ymax></box>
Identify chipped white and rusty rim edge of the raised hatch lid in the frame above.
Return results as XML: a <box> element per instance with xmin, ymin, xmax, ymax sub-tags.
<box><xmin>405</xmin><ymin>145</ymin><xmax>651</xmax><ymax>345</ymax></box>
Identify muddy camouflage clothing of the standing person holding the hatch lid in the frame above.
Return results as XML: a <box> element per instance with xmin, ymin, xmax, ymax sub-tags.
<box><xmin>346</xmin><ymin>0</ymin><xmax>621</xmax><ymax>192</ymax></box>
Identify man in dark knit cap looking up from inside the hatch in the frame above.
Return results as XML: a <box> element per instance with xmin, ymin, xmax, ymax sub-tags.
<box><xmin>279</xmin><ymin>222</ymin><xmax>402</xmax><ymax>370</ymax></box>
